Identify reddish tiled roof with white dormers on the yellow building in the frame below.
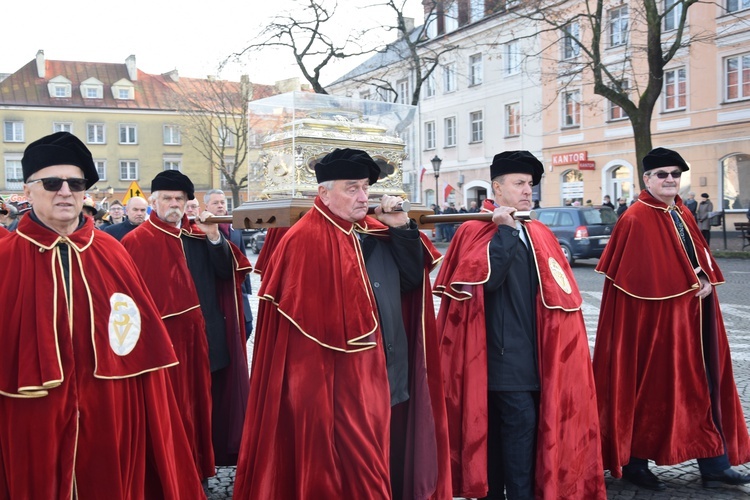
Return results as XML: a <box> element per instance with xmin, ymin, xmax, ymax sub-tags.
<box><xmin>0</xmin><ymin>59</ymin><xmax>277</xmax><ymax>110</ymax></box>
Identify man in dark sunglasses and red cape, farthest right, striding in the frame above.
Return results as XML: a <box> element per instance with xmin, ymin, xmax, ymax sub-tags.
<box><xmin>594</xmin><ymin>148</ymin><xmax>750</xmax><ymax>490</ymax></box>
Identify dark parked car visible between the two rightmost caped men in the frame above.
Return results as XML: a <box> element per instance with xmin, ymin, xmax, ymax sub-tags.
<box><xmin>535</xmin><ymin>207</ymin><xmax>617</xmax><ymax>264</ymax></box>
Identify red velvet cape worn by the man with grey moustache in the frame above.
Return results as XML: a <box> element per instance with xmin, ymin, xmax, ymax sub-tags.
<box><xmin>122</xmin><ymin>216</ymin><xmax>251</xmax><ymax>468</ymax></box>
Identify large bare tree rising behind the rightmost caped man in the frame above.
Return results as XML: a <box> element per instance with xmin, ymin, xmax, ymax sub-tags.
<box><xmin>514</xmin><ymin>0</ymin><xmax>714</xmax><ymax>189</ymax></box>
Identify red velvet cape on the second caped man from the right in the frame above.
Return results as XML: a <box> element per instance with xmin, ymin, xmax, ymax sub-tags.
<box><xmin>434</xmin><ymin>200</ymin><xmax>606</xmax><ymax>499</ymax></box>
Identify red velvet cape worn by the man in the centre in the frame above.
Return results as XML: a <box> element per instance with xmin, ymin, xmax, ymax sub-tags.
<box><xmin>235</xmin><ymin>199</ymin><xmax>450</xmax><ymax>498</ymax></box>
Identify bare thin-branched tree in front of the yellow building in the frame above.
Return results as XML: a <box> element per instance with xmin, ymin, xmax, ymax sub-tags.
<box><xmin>170</xmin><ymin>76</ymin><xmax>253</xmax><ymax>207</ymax></box>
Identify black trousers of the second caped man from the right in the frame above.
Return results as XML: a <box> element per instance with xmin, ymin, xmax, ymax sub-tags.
<box><xmin>486</xmin><ymin>391</ymin><xmax>539</xmax><ymax>500</ymax></box>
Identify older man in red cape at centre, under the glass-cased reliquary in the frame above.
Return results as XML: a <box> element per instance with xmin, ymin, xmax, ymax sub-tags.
<box><xmin>234</xmin><ymin>149</ymin><xmax>451</xmax><ymax>499</ymax></box>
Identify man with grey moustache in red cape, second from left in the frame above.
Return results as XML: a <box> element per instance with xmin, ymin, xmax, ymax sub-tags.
<box><xmin>122</xmin><ymin>170</ymin><xmax>251</xmax><ymax>480</ymax></box>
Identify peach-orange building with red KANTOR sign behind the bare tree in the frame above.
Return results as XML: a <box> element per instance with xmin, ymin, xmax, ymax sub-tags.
<box><xmin>542</xmin><ymin>0</ymin><xmax>750</xmax><ymax>229</ymax></box>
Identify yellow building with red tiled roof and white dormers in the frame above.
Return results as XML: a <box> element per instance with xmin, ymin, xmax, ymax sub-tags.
<box><xmin>0</xmin><ymin>50</ymin><xmax>287</xmax><ymax>211</ymax></box>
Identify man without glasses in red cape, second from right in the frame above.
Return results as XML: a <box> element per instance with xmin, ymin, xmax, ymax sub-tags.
<box><xmin>434</xmin><ymin>151</ymin><xmax>606</xmax><ymax>499</ymax></box>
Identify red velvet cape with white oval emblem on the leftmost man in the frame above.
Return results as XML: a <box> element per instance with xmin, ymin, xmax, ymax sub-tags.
<box><xmin>0</xmin><ymin>216</ymin><xmax>203</xmax><ymax>500</ymax></box>
